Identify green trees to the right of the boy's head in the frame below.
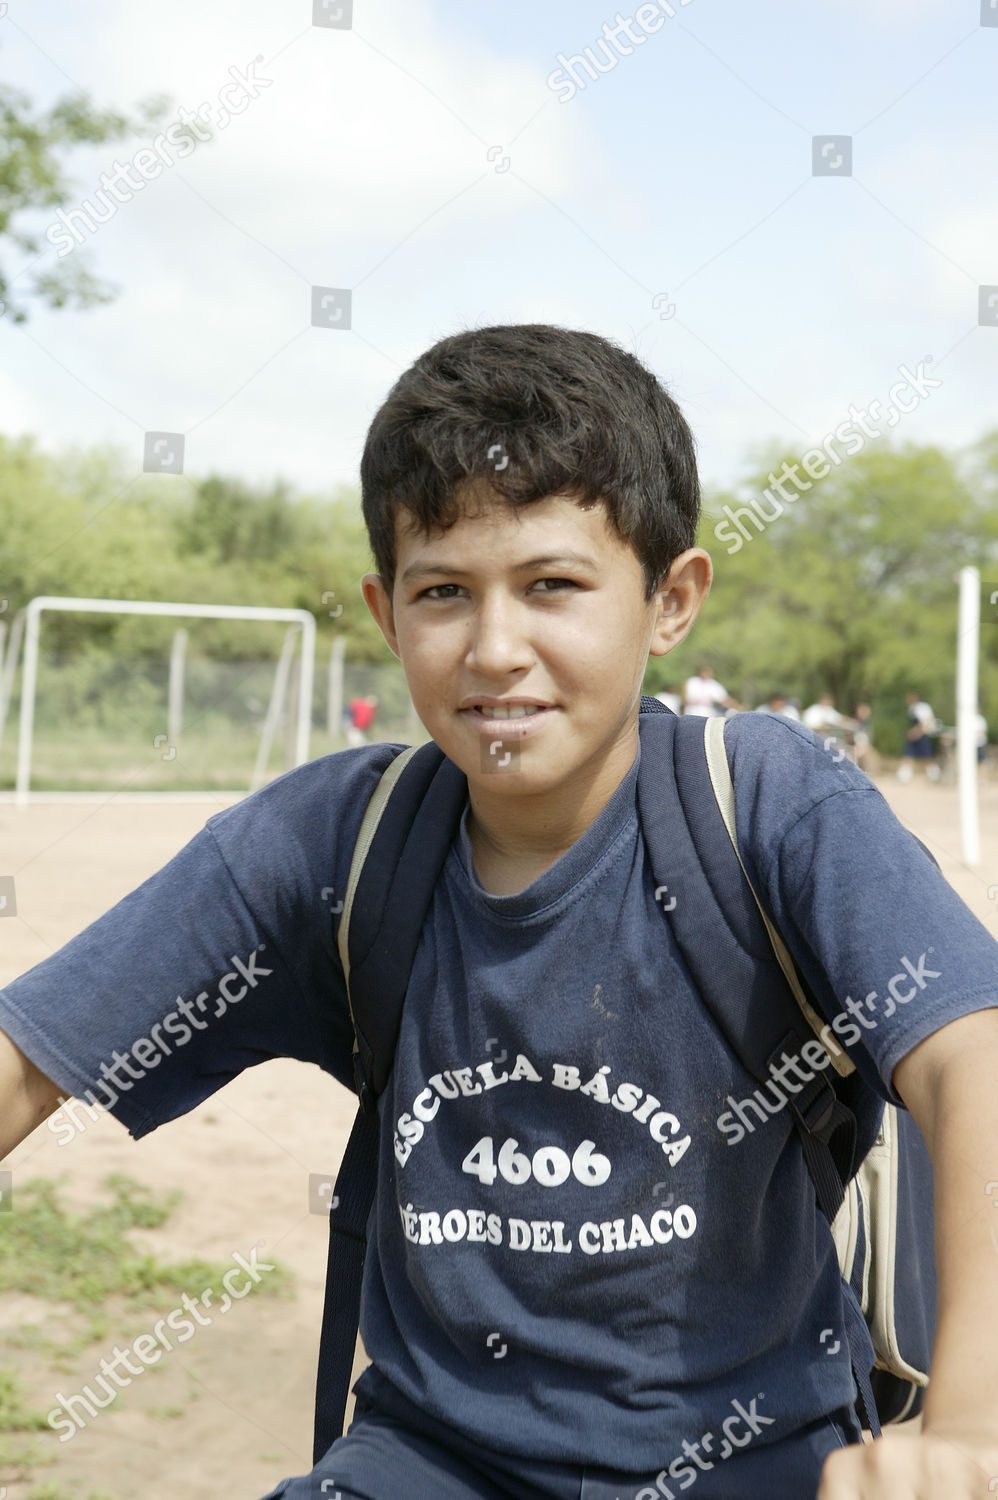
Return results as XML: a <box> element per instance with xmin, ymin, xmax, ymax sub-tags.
<box><xmin>648</xmin><ymin>434</ymin><xmax>998</xmax><ymax>750</ymax></box>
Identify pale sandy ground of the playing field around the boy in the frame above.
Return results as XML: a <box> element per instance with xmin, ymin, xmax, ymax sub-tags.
<box><xmin>0</xmin><ymin>779</ymin><xmax>998</xmax><ymax>1500</ymax></box>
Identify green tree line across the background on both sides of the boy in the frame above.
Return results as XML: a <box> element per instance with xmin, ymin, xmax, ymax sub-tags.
<box><xmin>0</xmin><ymin>432</ymin><xmax>998</xmax><ymax>749</ymax></box>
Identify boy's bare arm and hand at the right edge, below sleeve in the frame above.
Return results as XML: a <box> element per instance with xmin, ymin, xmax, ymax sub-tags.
<box><xmin>818</xmin><ymin>992</ymin><xmax>998</xmax><ymax>1500</ymax></box>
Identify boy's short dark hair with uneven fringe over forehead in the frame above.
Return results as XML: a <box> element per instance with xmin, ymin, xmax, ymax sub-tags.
<box><xmin>360</xmin><ymin>323</ymin><xmax>699</xmax><ymax>602</ymax></box>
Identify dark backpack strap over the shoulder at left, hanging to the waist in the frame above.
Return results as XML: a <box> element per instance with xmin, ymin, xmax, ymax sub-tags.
<box><xmin>312</xmin><ymin>741</ymin><xmax>468</xmax><ymax>1464</ymax></box>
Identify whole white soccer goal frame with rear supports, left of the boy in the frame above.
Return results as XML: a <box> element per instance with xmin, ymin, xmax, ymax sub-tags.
<box><xmin>12</xmin><ymin>596</ymin><xmax>315</xmax><ymax>806</ymax></box>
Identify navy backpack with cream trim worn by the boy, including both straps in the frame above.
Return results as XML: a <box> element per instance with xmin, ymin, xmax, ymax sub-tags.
<box><xmin>314</xmin><ymin>695</ymin><xmax>936</xmax><ymax>1463</ymax></box>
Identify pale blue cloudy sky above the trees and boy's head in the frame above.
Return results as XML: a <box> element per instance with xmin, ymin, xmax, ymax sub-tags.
<box><xmin>0</xmin><ymin>0</ymin><xmax>998</xmax><ymax>495</ymax></box>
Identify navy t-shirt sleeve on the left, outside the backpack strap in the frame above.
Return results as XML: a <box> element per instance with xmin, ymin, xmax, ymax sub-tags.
<box><xmin>0</xmin><ymin>744</ymin><xmax>402</xmax><ymax>1139</ymax></box>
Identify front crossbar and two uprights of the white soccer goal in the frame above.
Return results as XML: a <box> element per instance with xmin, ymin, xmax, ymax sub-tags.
<box><xmin>12</xmin><ymin>594</ymin><xmax>315</xmax><ymax>807</ymax></box>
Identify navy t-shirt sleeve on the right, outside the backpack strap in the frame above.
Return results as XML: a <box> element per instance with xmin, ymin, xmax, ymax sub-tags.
<box><xmin>726</xmin><ymin>714</ymin><xmax>998</xmax><ymax>1104</ymax></box>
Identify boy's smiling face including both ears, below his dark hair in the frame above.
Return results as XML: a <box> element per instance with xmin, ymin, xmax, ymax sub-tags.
<box><xmin>362</xmin><ymin>488</ymin><xmax>710</xmax><ymax>810</ymax></box>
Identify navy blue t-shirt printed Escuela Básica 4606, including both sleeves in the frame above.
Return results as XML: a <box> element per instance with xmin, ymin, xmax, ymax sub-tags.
<box><xmin>0</xmin><ymin>714</ymin><xmax>998</xmax><ymax>1475</ymax></box>
